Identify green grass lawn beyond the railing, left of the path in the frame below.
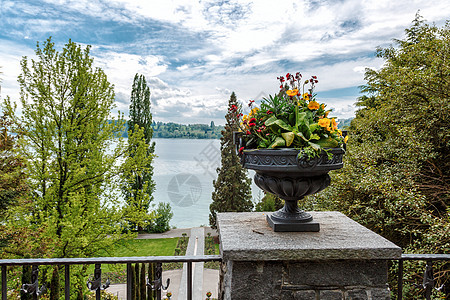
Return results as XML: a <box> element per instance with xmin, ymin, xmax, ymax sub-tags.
<box><xmin>88</xmin><ymin>238</ymin><xmax>178</xmax><ymax>274</ymax></box>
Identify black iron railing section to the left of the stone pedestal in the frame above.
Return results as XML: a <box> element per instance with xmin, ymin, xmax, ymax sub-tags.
<box><xmin>0</xmin><ymin>255</ymin><xmax>222</xmax><ymax>300</ymax></box>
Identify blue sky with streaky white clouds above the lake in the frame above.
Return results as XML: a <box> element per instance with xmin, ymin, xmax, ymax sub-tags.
<box><xmin>0</xmin><ymin>0</ymin><xmax>450</xmax><ymax>124</ymax></box>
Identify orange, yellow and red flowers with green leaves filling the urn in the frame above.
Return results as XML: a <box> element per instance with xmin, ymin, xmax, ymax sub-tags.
<box><xmin>237</xmin><ymin>72</ymin><xmax>346</xmax><ymax>158</ymax></box>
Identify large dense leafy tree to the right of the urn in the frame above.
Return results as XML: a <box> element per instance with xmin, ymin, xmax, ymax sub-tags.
<box><xmin>310</xmin><ymin>16</ymin><xmax>450</xmax><ymax>299</ymax></box>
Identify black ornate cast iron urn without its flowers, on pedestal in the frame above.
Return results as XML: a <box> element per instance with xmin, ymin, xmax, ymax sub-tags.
<box><xmin>234</xmin><ymin>133</ymin><xmax>345</xmax><ymax>232</ymax></box>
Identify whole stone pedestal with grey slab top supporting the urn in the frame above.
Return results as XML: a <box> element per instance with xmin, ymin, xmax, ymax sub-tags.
<box><xmin>217</xmin><ymin>212</ymin><xmax>401</xmax><ymax>300</ymax></box>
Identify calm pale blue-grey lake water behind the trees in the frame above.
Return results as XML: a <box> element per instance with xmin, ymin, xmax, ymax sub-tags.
<box><xmin>153</xmin><ymin>138</ymin><xmax>261</xmax><ymax>228</ymax></box>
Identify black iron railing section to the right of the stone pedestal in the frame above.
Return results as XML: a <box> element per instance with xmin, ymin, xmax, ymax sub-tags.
<box><xmin>397</xmin><ymin>254</ymin><xmax>450</xmax><ymax>300</ymax></box>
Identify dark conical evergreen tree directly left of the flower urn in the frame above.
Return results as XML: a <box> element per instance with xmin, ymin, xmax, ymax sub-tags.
<box><xmin>209</xmin><ymin>92</ymin><xmax>253</xmax><ymax>228</ymax></box>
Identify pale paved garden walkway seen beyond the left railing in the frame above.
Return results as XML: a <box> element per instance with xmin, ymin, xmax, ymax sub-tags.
<box><xmin>107</xmin><ymin>227</ymin><xmax>219</xmax><ymax>300</ymax></box>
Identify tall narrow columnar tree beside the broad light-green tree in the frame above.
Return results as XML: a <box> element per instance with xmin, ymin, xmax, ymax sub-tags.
<box><xmin>123</xmin><ymin>74</ymin><xmax>155</xmax><ymax>230</ymax></box>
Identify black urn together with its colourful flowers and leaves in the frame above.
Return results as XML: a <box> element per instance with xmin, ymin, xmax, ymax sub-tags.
<box><xmin>234</xmin><ymin>73</ymin><xmax>347</xmax><ymax>231</ymax></box>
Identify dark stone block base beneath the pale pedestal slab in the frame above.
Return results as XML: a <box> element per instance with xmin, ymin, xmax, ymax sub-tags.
<box><xmin>222</xmin><ymin>261</ymin><xmax>390</xmax><ymax>300</ymax></box>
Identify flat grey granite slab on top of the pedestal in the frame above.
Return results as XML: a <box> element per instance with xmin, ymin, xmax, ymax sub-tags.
<box><xmin>217</xmin><ymin>212</ymin><xmax>402</xmax><ymax>261</ymax></box>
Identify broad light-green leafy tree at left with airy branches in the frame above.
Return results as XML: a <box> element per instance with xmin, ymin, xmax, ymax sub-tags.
<box><xmin>5</xmin><ymin>38</ymin><xmax>134</xmax><ymax>257</ymax></box>
